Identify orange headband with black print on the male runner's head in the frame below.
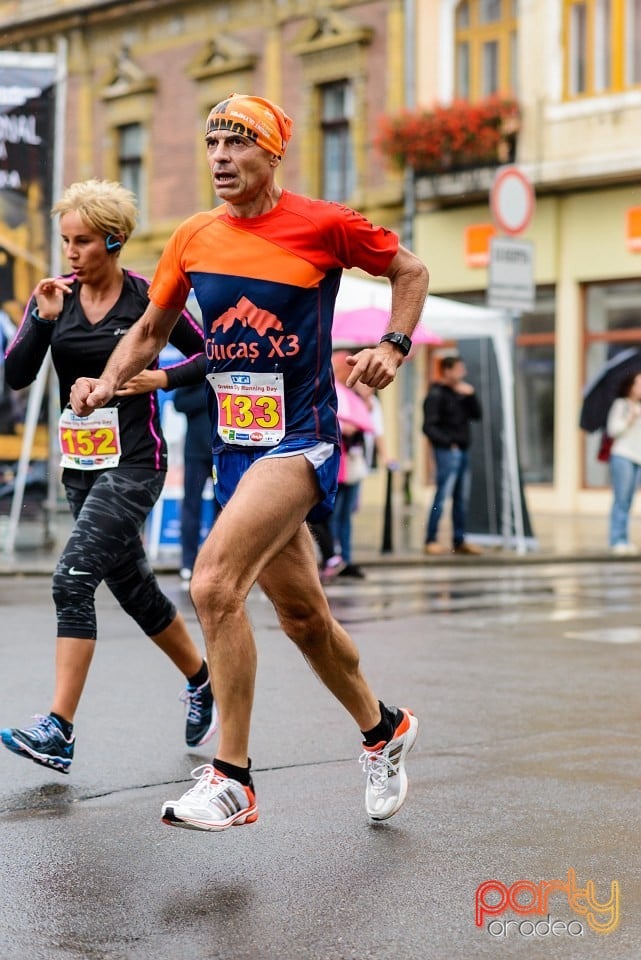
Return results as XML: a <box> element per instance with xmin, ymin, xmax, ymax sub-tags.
<box><xmin>205</xmin><ymin>93</ymin><xmax>294</xmax><ymax>157</ymax></box>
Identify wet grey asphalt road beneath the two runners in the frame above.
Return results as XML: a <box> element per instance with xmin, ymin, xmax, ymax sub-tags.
<box><xmin>0</xmin><ymin>563</ymin><xmax>641</xmax><ymax>960</ymax></box>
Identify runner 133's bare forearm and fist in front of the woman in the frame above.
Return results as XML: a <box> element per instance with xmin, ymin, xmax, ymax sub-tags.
<box><xmin>70</xmin><ymin>303</ymin><xmax>181</xmax><ymax>417</ymax></box>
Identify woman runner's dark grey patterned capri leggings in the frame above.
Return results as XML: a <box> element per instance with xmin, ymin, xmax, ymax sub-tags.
<box><xmin>52</xmin><ymin>467</ymin><xmax>176</xmax><ymax>640</ymax></box>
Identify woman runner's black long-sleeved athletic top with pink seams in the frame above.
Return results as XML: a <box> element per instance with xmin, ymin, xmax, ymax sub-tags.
<box><xmin>5</xmin><ymin>270</ymin><xmax>205</xmax><ymax>470</ymax></box>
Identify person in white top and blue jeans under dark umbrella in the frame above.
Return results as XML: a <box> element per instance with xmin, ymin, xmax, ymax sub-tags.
<box><xmin>606</xmin><ymin>373</ymin><xmax>641</xmax><ymax>556</ymax></box>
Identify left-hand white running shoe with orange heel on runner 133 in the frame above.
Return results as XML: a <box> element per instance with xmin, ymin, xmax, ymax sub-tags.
<box><xmin>161</xmin><ymin>763</ymin><xmax>258</xmax><ymax>831</ymax></box>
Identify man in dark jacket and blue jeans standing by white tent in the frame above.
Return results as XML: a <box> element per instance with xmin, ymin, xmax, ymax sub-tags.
<box><xmin>423</xmin><ymin>356</ymin><xmax>482</xmax><ymax>554</ymax></box>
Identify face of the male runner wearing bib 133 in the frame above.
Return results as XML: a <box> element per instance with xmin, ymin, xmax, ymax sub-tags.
<box><xmin>205</xmin><ymin>130</ymin><xmax>274</xmax><ymax>207</ymax></box>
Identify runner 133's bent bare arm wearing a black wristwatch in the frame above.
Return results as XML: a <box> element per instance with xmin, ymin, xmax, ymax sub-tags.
<box><xmin>347</xmin><ymin>246</ymin><xmax>429</xmax><ymax>390</ymax></box>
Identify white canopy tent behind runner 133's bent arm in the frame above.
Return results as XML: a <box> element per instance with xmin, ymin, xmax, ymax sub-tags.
<box><xmin>336</xmin><ymin>273</ymin><xmax>527</xmax><ymax>553</ymax></box>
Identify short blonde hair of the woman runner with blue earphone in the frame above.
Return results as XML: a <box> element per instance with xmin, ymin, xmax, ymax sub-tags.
<box><xmin>51</xmin><ymin>180</ymin><xmax>138</xmax><ymax>243</ymax></box>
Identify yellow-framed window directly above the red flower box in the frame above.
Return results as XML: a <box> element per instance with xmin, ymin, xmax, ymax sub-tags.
<box><xmin>455</xmin><ymin>0</ymin><xmax>517</xmax><ymax>100</ymax></box>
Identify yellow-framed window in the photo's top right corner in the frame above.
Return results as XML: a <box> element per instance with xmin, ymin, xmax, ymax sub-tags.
<box><xmin>564</xmin><ymin>0</ymin><xmax>641</xmax><ymax>98</ymax></box>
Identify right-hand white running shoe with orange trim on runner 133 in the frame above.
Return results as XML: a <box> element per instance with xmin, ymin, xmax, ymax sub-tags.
<box><xmin>359</xmin><ymin>708</ymin><xmax>418</xmax><ymax>820</ymax></box>
